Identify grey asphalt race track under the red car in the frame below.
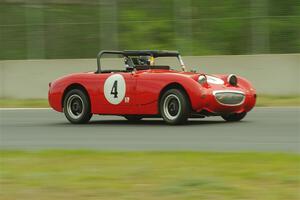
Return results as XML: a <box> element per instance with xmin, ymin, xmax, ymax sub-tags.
<box><xmin>0</xmin><ymin>107</ymin><xmax>300</xmax><ymax>152</ymax></box>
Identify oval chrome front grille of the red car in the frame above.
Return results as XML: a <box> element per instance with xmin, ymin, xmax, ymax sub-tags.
<box><xmin>213</xmin><ymin>90</ymin><xmax>245</xmax><ymax>106</ymax></box>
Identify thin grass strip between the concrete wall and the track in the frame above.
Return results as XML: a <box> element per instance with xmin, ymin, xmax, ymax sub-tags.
<box><xmin>0</xmin><ymin>95</ymin><xmax>300</xmax><ymax>108</ymax></box>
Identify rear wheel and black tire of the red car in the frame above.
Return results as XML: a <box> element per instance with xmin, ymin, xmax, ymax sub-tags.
<box><xmin>63</xmin><ymin>89</ymin><xmax>92</xmax><ymax>124</ymax></box>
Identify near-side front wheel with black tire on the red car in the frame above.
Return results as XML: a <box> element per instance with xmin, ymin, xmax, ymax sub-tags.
<box><xmin>159</xmin><ymin>89</ymin><xmax>190</xmax><ymax>125</ymax></box>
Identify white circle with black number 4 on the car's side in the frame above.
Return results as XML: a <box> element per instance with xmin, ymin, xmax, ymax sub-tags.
<box><xmin>104</xmin><ymin>74</ymin><xmax>126</xmax><ymax>105</ymax></box>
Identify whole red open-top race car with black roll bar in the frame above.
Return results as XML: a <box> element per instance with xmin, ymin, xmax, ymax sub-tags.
<box><xmin>48</xmin><ymin>50</ymin><xmax>256</xmax><ymax>124</ymax></box>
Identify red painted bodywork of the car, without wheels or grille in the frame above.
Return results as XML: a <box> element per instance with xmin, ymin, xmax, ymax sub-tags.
<box><xmin>48</xmin><ymin>69</ymin><xmax>256</xmax><ymax>115</ymax></box>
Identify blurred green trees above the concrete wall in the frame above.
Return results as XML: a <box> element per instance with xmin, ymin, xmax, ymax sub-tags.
<box><xmin>0</xmin><ymin>0</ymin><xmax>300</xmax><ymax>60</ymax></box>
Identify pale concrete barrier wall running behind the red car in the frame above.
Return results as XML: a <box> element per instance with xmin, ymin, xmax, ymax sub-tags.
<box><xmin>0</xmin><ymin>54</ymin><xmax>300</xmax><ymax>98</ymax></box>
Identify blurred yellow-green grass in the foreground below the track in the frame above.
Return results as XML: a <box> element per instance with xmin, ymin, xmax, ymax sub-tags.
<box><xmin>0</xmin><ymin>151</ymin><xmax>300</xmax><ymax>200</ymax></box>
